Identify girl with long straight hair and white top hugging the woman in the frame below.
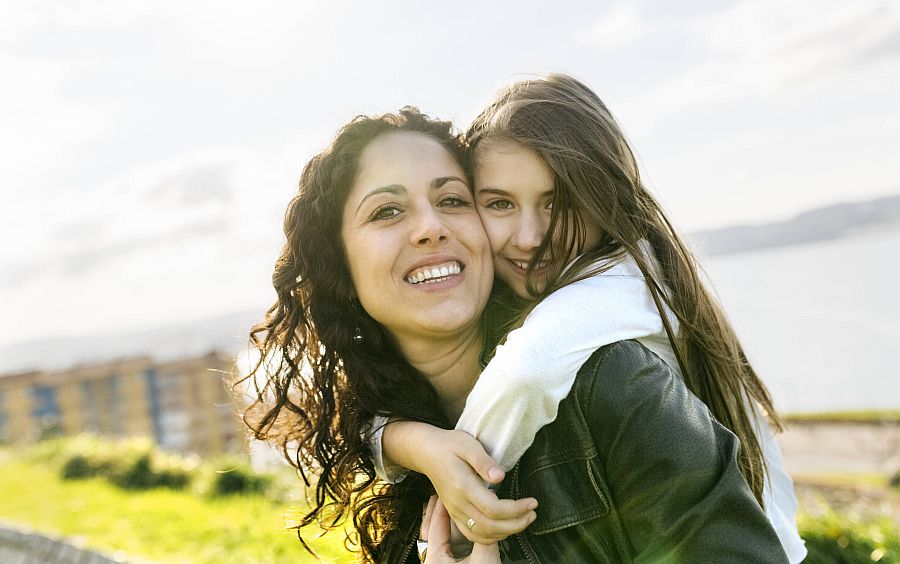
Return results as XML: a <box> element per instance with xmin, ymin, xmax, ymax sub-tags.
<box><xmin>376</xmin><ymin>75</ymin><xmax>805</xmax><ymax>562</ymax></box>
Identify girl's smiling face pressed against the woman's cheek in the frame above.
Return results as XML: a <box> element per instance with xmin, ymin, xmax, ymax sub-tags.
<box><xmin>475</xmin><ymin>140</ymin><xmax>599</xmax><ymax>299</ymax></box>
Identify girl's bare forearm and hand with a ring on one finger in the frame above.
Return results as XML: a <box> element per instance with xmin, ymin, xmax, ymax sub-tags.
<box><xmin>382</xmin><ymin>421</ymin><xmax>538</xmax><ymax>544</ymax></box>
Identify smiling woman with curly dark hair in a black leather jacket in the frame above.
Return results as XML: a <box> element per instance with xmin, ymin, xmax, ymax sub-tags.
<box><xmin>246</xmin><ymin>104</ymin><xmax>784</xmax><ymax>562</ymax></box>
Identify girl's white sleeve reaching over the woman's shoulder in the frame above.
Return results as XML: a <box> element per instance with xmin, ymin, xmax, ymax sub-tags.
<box><xmin>456</xmin><ymin>253</ymin><xmax>663</xmax><ymax>469</ymax></box>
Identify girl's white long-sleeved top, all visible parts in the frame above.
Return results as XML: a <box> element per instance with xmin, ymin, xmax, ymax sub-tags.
<box><xmin>372</xmin><ymin>249</ymin><xmax>806</xmax><ymax>563</ymax></box>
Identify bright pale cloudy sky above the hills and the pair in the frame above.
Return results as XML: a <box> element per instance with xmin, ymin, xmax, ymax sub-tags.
<box><xmin>0</xmin><ymin>0</ymin><xmax>900</xmax><ymax>344</ymax></box>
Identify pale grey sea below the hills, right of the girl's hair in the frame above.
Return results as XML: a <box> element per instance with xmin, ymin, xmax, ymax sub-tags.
<box><xmin>700</xmin><ymin>229</ymin><xmax>900</xmax><ymax>414</ymax></box>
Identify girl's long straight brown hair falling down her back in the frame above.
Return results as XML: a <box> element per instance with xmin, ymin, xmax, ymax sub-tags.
<box><xmin>466</xmin><ymin>75</ymin><xmax>781</xmax><ymax>504</ymax></box>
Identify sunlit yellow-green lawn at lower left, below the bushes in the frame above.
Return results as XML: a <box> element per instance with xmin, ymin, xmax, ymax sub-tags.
<box><xmin>0</xmin><ymin>456</ymin><xmax>354</xmax><ymax>563</ymax></box>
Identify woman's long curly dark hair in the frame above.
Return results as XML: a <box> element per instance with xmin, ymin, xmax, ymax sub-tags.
<box><xmin>240</xmin><ymin>107</ymin><xmax>463</xmax><ymax>561</ymax></box>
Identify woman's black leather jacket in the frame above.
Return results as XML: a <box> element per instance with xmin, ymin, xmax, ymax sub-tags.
<box><xmin>395</xmin><ymin>341</ymin><xmax>788</xmax><ymax>564</ymax></box>
